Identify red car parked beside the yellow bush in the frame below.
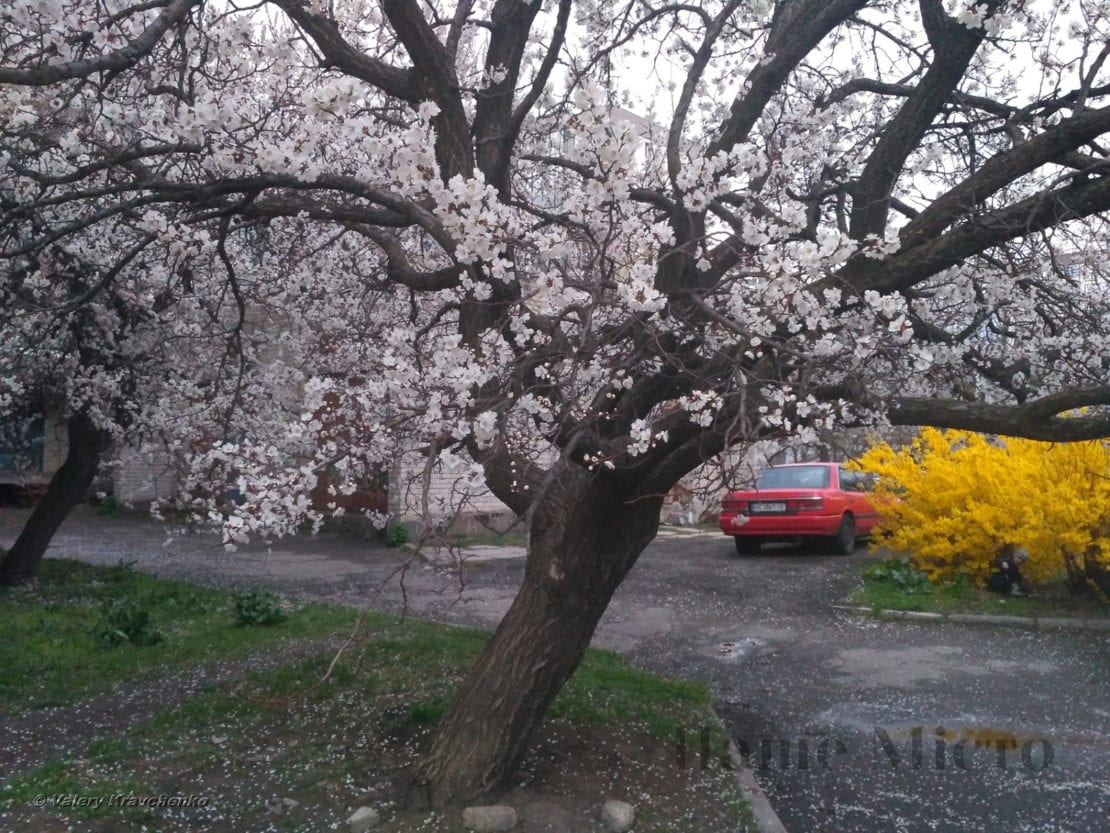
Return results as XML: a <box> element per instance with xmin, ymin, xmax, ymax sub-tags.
<box><xmin>720</xmin><ymin>463</ymin><xmax>879</xmax><ymax>555</ymax></box>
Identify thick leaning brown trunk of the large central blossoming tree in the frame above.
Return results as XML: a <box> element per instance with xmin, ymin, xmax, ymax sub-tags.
<box><xmin>415</xmin><ymin>468</ymin><xmax>663</xmax><ymax>807</ymax></box>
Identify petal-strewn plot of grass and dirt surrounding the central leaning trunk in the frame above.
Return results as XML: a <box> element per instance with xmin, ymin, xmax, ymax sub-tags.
<box><xmin>0</xmin><ymin>622</ymin><xmax>746</xmax><ymax>833</ymax></box>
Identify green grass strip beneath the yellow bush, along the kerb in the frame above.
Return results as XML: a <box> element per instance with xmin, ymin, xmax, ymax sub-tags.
<box><xmin>851</xmin><ymin>560</ymin><xmax>1110</xmax><ymax>618</ymax></box>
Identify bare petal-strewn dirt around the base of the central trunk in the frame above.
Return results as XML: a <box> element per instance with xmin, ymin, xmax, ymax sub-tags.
<box><xmin>0</xmin><ymin>709</ymin><xmax>747</xmax><ymax>833</ymax></box>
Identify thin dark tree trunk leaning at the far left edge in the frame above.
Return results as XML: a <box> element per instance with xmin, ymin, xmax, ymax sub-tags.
<box><xmin>0</xmin><ymin>413</ymin><xmax>111</xmax><ymax>585</ymax></box>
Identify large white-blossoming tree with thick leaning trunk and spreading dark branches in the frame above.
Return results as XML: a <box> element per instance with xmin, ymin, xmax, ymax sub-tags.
<box><xmin>0</xmin><ymin>0</ymin><xmax>1110</xmax><ymax>804</ymax></box>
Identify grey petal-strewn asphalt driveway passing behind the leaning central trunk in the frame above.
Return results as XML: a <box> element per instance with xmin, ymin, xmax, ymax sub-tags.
<box><xmin>0</xmin><ymin>510</ymin><xmax>1110</xmax><ymax>833</ymax></box>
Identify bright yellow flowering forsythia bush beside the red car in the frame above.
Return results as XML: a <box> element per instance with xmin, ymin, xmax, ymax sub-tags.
<box><xmin>852</xmin><ymin>428</ymin><xmax>1110</xmax><ymax>583</ymax></box>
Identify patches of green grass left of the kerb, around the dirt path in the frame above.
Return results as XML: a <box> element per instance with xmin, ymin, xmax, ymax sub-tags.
<box><xmin>0</xmin><ymin>561</ymin><xmax>712</xmax><ymax>760</ymax></box>
